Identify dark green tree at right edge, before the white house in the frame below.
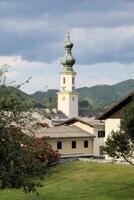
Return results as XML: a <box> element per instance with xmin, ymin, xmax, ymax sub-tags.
<box><xmin>105</xmin><ymin>96</ymin><xmax>134</xmax><ymax>165</ymax></box>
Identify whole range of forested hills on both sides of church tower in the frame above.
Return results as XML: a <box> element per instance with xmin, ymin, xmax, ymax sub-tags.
<box><xmin>0</xmin><ymin>79</ymin><xmax>134</xmax><ymax>110</ymax></box>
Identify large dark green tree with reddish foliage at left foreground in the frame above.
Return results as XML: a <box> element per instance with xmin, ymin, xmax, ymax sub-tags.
<box><xmin>0</xmin><ymin>67</ymin><xmax>58</xmax><ymax>192</ymax></box>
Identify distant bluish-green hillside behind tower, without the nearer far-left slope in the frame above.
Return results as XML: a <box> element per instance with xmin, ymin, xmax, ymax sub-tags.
<box><xmin>31</xmin><ymin>79</ymin><xmax>134</xmax><ymax>109</ymax></box>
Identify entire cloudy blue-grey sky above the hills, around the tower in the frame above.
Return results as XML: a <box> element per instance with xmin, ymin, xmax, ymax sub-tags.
<box><xmin>0</xmin><ymin>0</ymin><xmax>134</xmax><ymax>93</ymax></box>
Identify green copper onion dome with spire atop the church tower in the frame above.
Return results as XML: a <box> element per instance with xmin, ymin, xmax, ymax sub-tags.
<box><xmin>61</xmin><ymin>33</ymin><xmax>75</xmax><ymax>71</ymax></box>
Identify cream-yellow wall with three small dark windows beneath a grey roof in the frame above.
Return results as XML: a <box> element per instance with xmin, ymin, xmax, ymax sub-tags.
<box><xmin>48</xmin><ymin>138</ymin><xmax>93</xmax><ymax>155</ymax></box>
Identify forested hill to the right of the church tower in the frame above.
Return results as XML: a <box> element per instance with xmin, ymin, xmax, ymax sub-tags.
<box><xmin>77</xmin><ymin>79</ymin><xmax>134</xmax><ymax>108</ymax></box>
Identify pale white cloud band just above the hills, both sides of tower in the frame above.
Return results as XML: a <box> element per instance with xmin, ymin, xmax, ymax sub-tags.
<box><xmin>0</xmin><ymin>56</ymin><xmax>134</xmax><ymax>93</ymax></box>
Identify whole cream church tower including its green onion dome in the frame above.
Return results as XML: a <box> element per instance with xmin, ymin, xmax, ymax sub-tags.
<box><xmin>58</xmin><ymin>33</ymin><xmax>78</xmax><ymax>118</ymax></box>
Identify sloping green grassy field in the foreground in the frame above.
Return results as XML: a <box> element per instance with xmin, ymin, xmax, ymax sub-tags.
<box><xmin>0</xmin><ymin>161</ymin><xmax>134</xmax><ymax>200</ymax></box>
